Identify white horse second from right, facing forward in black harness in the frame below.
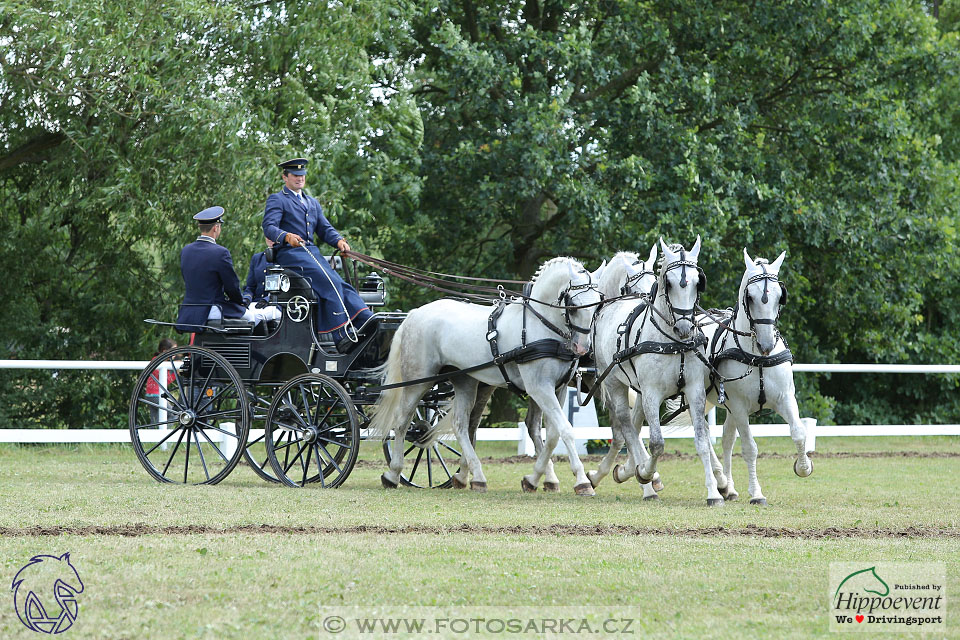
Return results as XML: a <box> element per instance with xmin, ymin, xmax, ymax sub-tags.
<box><xmin>594</xmin><ymin>236</ymin><xmax>727</xmax><ymax>506</ymax></box>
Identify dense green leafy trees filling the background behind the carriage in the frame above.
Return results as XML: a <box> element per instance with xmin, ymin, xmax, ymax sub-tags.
<box><xmin>0</xmin><ymin>0</ymin><xmax>960</xmax><ymax>427</ymax></box>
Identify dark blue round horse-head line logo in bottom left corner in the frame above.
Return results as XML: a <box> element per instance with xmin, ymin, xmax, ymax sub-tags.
<box><xmin>10</xmin><ymin>552</ymin><xmax>83</xmax><ymax>634</ymax></box>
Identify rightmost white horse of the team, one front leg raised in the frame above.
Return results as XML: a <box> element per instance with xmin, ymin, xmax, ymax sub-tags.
<box><xmin>701</xmin><ymin>249</ymin><xmax>813</xmax><ymax>505</ymax></box>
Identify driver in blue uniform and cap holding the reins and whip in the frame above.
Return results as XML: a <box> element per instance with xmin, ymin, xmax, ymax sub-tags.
<box><xmin>263</xmin><ymin>158</ymin><xmax>376</xmax><ymax>353</ymax></box>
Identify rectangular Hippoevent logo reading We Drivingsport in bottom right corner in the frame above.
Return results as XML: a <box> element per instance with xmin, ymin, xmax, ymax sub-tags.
<box><xmin>830</xmin><ymin>562</ymin><xmax>946</xmax><ymax>633</ymax></box>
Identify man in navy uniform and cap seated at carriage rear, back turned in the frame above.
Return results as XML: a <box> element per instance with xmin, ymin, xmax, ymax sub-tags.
<box><xmin>176</xmin><ymin>207</ymin><xmax>255</xmax><ymax>332</ymax></box>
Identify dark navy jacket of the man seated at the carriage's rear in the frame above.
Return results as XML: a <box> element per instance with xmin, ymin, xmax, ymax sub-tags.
<box><xmin>177</xmin><ymin>236</ymin><xmax>246</xmax><ymax>332</ymax></box>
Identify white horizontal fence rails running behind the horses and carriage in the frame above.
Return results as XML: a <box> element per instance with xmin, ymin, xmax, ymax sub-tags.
<box><xmin>0</xmin><ymin>360</ymin><xmax>960</xmax><ymax>450</ymax></box>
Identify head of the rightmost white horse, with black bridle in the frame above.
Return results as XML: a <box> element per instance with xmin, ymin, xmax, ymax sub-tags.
<box><xmin>738</xmin><ymin>249</ymin><xmax>787</xmax><ymax>356</ymax></box>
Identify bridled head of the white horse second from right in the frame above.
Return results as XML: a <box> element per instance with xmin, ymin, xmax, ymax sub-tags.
<box><xmin>654</xmin><ymin>235</ymin><xmax>707</xmax><ymax>340</ymax></box>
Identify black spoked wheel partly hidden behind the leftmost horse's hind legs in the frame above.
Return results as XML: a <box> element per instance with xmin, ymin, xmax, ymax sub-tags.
<box><xmin>383</xmin><ymin>400</ymin><xmax>461</xmax><ymax>489</ymax></box>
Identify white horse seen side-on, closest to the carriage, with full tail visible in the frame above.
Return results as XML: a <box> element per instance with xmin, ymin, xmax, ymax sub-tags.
<box><xmin>368</xmin><ymin>258</ymin><xmax>602</xmax><ymax>495</ymax></box>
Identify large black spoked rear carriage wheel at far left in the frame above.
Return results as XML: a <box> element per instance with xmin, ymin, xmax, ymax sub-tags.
<box><xmin>130</xmin><ymin>346</ymin><xmax>250</xmax><ymax>484</ymax></box>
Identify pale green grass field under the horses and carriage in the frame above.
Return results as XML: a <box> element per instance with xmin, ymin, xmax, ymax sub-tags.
<box><xmin>0</xmin><ymin>437</ymin><xmax>960</xmax><ymax>638</ymax></box>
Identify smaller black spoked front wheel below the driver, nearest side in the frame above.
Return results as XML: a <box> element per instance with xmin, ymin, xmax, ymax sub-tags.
<box><xmin>264</xmin><ymin>373</ymin><xmax>360</xmax><ymax>488</ymax></box>
